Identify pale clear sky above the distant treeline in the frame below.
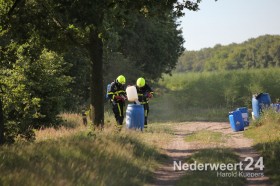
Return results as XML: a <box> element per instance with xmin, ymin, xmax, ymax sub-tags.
<box><xmin>179</xmin><ymin>0</ymin><xmax>280</xmax><ymax>50</ymax></box>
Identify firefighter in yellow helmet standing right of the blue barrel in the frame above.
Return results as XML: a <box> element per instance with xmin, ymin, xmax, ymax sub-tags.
<box><xmin>136</xmin><ymin>77</ymin><xmax>154</xmax><ymax>128</ymax></box>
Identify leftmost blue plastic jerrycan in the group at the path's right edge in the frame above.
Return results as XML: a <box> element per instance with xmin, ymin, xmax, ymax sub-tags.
<box><xmin>228</xmin><ymin>110</ymin><xmax>244</xmax><ymax>132</ymax></box>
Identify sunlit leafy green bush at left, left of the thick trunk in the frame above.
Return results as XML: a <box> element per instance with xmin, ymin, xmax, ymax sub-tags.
<box><xmin>1</xmin><ymin>44</ymin><xmax>71</xmax><ymax>141</ymax></box>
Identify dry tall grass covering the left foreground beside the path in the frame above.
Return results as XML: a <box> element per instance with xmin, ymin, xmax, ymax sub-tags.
<box><xmin>0</xmin><ymin>113</ymin><xmax>172</xmax><ymax>186</ymax></box>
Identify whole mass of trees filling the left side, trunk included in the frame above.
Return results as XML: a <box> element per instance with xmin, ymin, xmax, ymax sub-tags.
<box><xmin>0</xmin><ymin>0</ymin><xmax>200</xmax><ymax>143</ymax></box>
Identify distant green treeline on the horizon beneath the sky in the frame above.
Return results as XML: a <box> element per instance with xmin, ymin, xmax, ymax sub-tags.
<box><xmin>176</xmin><ymin>35</ymin><xmax>280</xmax><ymax>72</ymax></box>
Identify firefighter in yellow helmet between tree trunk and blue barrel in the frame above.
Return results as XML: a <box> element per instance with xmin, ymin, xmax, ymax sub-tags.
<box><xmin>108</xmin><ymin>75</ymin><xmax>126</xmax><ymax>130</ymax></box>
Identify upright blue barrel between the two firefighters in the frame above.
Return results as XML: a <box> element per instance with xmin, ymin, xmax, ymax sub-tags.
<box><xmin>126</xmin><ymin>104</ymin><xmax>145</xmax><ymax>130</ymax></box>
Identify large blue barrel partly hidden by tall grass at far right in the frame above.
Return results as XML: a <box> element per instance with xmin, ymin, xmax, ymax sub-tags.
<box><xmin>252</xmin><ymin>93</ymin><xmax>271</xmax><ymax>119</ymax></box>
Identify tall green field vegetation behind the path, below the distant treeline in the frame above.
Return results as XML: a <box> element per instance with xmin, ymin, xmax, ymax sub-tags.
<box><xmin>150</xmin><ymin>68</ymin><xmax>280</xmax><ymax>121</ymax></box>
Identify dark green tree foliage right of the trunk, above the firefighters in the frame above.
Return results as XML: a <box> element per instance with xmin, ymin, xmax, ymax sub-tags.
<box><xmin>103</xmin><ymin>10</ymin><xmax>184</xmax><ymax>83</ymax></box>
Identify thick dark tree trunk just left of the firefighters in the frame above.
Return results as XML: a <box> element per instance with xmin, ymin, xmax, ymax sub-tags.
<box><xmin>88</xmin><ymin>30</ymin><xmax>104</xmax><ymax>127</ymax></box>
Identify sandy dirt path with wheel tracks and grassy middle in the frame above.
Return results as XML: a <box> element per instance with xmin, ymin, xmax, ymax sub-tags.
<box><xmin>149</xmin><ymin>122</ymin><xmax>272</xmax><ymax>186</ymax></box>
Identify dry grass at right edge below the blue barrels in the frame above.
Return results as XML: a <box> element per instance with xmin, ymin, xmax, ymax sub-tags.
<box><xmin>245</xmin><ymin>110</ymin><xmax>280</xmax><ymax>185</ymax></box>
